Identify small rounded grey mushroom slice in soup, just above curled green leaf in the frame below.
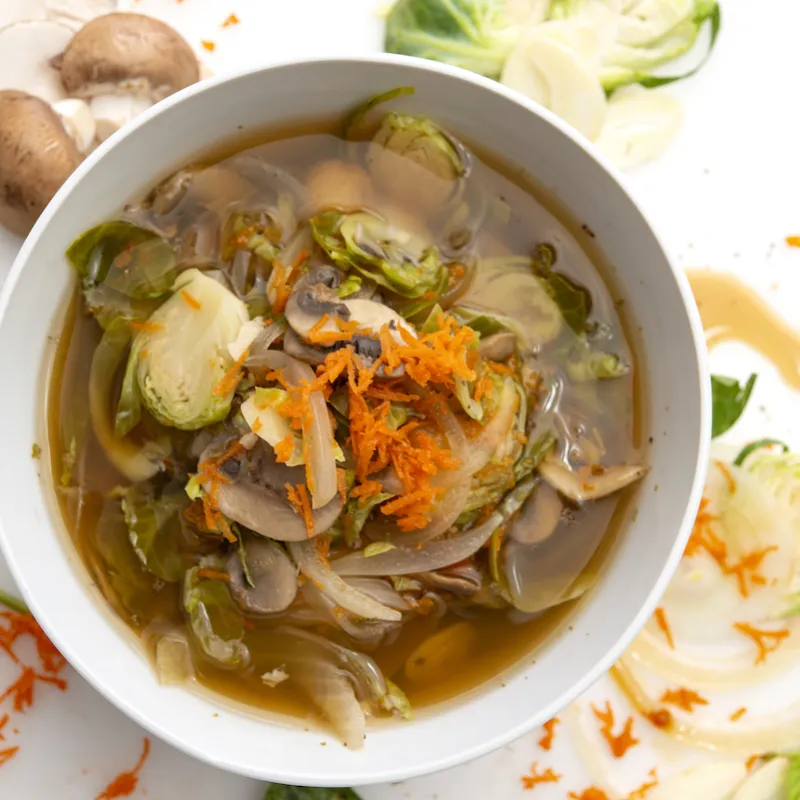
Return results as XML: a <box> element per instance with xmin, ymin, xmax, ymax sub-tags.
<box><xmin>227</xmin><ymin>538</ymin><xmax>297</xmax><ymax>615</ymax></box>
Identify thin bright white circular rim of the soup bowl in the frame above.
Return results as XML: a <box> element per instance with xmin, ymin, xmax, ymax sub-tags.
<box><xmin>0</xmin><ymin>53</ymin><xmax>711</xmax><ymax>787</ymax></box>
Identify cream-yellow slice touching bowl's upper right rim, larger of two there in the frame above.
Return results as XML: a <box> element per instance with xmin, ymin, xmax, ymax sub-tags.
<box><xmin>501</xmin><ymin>25</ymin><xmax>606</xmax><ymax>139</ymax></box>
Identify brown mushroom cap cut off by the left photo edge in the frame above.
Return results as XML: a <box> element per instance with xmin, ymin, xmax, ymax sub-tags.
<box><xmin>0</xmin><ymin>91</ymin><xmax>81</xmax><ymax>236</ymax></box>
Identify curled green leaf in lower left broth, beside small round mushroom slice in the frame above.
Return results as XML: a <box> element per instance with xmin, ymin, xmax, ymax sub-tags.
<box><xmin>183</xmin><ymin>567</ymin><xmax>250</xmax><ymax>667</ymax></box>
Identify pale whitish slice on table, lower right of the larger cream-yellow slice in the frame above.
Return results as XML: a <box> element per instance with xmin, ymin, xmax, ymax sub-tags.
<box><xmin>595</xmin><ymin>86</ymin><xmax>683</xmax><ymax>169</ymax></box>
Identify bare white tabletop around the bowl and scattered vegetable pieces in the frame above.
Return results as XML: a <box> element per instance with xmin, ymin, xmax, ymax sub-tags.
<box><xmin>0</xmin><ymin>0</ymin><xmax>800</xmax><ymax>800</ymax></box>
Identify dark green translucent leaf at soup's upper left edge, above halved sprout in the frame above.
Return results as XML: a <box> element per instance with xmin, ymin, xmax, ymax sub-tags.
<box><xmin>67</xmin><ymin>220</ymin><xmax>176</xmax><ymax>300</ymax></box>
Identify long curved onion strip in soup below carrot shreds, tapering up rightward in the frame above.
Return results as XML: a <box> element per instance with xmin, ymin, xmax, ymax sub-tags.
<box><xmin>331</xmin><ymin>513</ymin><xmax>503</xmax><ymax>576</ymax></box>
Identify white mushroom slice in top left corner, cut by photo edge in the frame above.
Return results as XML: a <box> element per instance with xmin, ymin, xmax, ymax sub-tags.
<box><xmin>0</xmin><ymin>20</ymin><xmax>72</xmax><ymax>103</ymax></box>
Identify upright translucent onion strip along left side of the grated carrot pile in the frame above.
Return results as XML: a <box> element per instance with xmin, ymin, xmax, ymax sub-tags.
<box><xmin>252</xmin><ymin>350</ymin><xmax>338</xmax><ymax>508</ymax></box>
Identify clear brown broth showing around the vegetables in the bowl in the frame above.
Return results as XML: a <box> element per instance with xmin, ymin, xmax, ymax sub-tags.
<box><xmin>48</xmin><ymin>115</ymin><xmax>642</xmax><ymax>736</ymax></box>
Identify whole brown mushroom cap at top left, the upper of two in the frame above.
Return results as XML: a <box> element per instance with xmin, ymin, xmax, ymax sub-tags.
<box><xmin>59</xmin><ymin>14</ymin><xmax>200</xmax><ymax>101</ymax></box>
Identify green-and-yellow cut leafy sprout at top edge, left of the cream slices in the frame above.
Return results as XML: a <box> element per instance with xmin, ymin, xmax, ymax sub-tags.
<box><xmin>385</xmin><ymin>0</ymin><xmax>520</xmax><ymax>78</ymax></box>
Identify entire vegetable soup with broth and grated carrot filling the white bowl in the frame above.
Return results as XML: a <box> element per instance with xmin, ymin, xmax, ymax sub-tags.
<box><xmin>50</xmin><ymin>93</ymin><xmax>644</xmax><ymax>747</ymax></box>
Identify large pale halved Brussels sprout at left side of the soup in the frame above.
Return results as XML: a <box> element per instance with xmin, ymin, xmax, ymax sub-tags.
<box><xmin>129</xmin><ymin>269</ymin><xmax>248</xmax><ymax>431</ymax></box>
